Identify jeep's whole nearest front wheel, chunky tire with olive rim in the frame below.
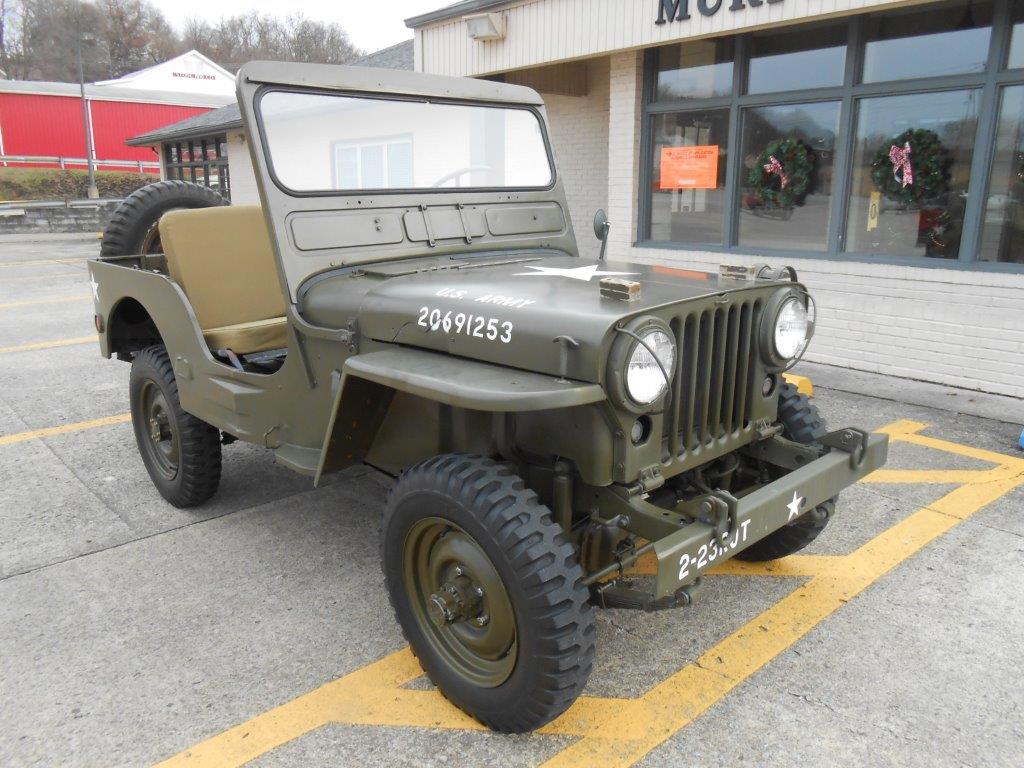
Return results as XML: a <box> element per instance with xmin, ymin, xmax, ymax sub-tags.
<box><xmin>381</xmin><ymin>455</ymin><xmax>595</xmax><ymax>732</ymax></box>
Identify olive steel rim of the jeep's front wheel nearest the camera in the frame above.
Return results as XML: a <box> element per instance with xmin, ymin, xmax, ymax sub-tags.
<box><xmin>402</xmin><ymin>517</ymin><xmax>518</xmax><ymax>688</ymax></box>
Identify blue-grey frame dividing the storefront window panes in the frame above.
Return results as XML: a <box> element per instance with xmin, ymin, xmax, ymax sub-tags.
<box><xmin>634</xmin><ymin>0</ymin><xmax>1024</xmax><ymax>272</ymax></box>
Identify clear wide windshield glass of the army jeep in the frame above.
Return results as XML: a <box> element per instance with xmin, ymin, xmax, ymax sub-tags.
<box><xmin>259</xmin><ymin>91</ymin><xmax>552</xmax><ymax>193</ymax></box>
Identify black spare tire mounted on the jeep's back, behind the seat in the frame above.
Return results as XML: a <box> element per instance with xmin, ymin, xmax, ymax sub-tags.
<box><xmin>99</xmin><ymin>181</ymin><xmax>227</xmax><ymax>257</ymax></box>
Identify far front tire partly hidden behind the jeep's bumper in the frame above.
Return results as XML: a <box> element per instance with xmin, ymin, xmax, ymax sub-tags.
<box><xmin>736</xmin><ymin>383</ymin><xmax>836</xmax><ymax>562</ymax></box>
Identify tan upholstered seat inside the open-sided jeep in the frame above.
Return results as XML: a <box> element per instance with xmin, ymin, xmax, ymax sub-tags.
<box><xmin>160</xmin><ymin>206</ymin><xmax>288</xmax><ymax>356</ymax></box>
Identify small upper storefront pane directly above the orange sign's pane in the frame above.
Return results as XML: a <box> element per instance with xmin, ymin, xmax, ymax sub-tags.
<box><xmin>655</xmin><ymin>38</ymin><xmax>736</xmax><ymax>100</ymax></box>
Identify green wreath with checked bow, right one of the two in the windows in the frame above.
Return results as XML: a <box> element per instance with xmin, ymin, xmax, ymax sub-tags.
<box><xmin>871</xmin><ymin>128</ymin><xmax>949</xmax><ymax>206</ymax></box>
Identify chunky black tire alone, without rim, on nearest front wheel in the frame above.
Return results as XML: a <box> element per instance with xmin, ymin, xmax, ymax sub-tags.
<box><xmin>381</xmin><ymin>454</ymin><xmax>596</xmax><ymax>733</ymax></box>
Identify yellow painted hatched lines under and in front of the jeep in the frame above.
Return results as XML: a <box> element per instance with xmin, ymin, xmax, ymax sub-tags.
<box><xmin>160</xmin><ymin>422</ymin><xmax>1024</xmax><ymax>768</ymax></box>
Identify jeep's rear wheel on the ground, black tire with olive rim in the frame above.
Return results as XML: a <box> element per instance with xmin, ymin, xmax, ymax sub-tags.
<box><xmin>129</xmin><ymin>346</ymin><xmax>220</xmax><ymax>508</ymax></box>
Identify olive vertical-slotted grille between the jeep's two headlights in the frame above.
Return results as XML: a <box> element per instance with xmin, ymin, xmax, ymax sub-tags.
<box><xmin>667</xmin><ymin>298</ymin><xmax>761</xmax><ymax>460</ymax></box>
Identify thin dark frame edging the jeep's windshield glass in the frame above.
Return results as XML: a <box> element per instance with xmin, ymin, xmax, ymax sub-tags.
<box><xmin>253</xmin><ymin>85</ymin><xmax>558</xmax><ymax>198</ymax></box>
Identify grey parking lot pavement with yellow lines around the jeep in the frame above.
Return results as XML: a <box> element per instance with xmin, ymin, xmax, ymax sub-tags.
<box><xmin>0</xmin><ymin>239</ymin><xmax>1024</xmax><ymax>768</ymax></box>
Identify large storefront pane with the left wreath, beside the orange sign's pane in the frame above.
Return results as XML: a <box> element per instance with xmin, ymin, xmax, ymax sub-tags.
<box><xmin>739</xmin><ymin>101</ymin><xmax>840</xmax><ymax>251</ymax></box>
